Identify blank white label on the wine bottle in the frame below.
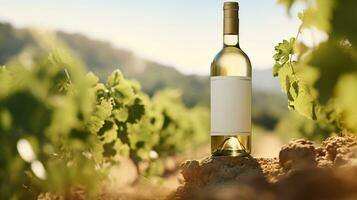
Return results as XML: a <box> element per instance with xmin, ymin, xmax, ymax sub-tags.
<box><xmin>211</xmin><ymin>76</ymin><xmax>252</xmax><ymax>135</ymax></box>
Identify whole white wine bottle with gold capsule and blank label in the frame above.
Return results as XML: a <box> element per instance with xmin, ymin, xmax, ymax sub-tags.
<box><xmin>210</xmin><ymin>2</ymin><xmax>252</xmax><ymax>156</ymax></box>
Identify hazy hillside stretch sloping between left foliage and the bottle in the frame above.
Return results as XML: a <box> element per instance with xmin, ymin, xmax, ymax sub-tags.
<box><xmin>57</xmin><ymin>32</ymin><xmax>209</xmax><ymax>106</ymax></box>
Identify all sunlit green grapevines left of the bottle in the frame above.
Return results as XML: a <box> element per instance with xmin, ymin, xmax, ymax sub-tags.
<box><xmin>0</xmin><ymin>33</ymin><xmax>208</xmax><ymax>199</ymax></box>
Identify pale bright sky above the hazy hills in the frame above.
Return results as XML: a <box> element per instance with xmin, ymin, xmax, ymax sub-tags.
<box><xmin>0</xmin><ymin>0</ymin><xmax>299</xmax><ymax>75</ymax></box>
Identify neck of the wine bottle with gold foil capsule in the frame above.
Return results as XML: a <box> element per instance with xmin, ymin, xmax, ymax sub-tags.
<box><xmin>223</xmin><ymin>2</ymin><xmax>239</xmax><ymax>48</ymax></box>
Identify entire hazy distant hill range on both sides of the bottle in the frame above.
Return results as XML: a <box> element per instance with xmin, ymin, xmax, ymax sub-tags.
<box><xmin>0</xmin><ymin>23</ymin><xmax>280</xmax><ymax>111</ymax></box>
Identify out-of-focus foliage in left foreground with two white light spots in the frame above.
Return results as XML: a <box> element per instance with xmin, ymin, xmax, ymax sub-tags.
<box><xmin>0</xmin><ymin>32</ymin><xmax>100</xmax><ymax>199</ymax></box>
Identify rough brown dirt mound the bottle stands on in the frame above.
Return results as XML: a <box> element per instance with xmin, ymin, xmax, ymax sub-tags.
<box><xmin>168</xmin><ymin>136</ymin><xmax>357</xmax><ymax>200</ymax></box>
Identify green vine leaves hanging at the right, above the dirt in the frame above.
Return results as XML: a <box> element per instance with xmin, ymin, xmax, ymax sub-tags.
<box><xmin>273</xmin><ymin>0</ymin><xmax>357</xmax><ymax>138</ymax></box>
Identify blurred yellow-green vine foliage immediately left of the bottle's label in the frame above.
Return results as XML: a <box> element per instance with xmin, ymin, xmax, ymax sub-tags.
<box><xmin>153</xmin><ymin>90</ymin><xmax>209</xmax><ymax>155</ymax></box>
